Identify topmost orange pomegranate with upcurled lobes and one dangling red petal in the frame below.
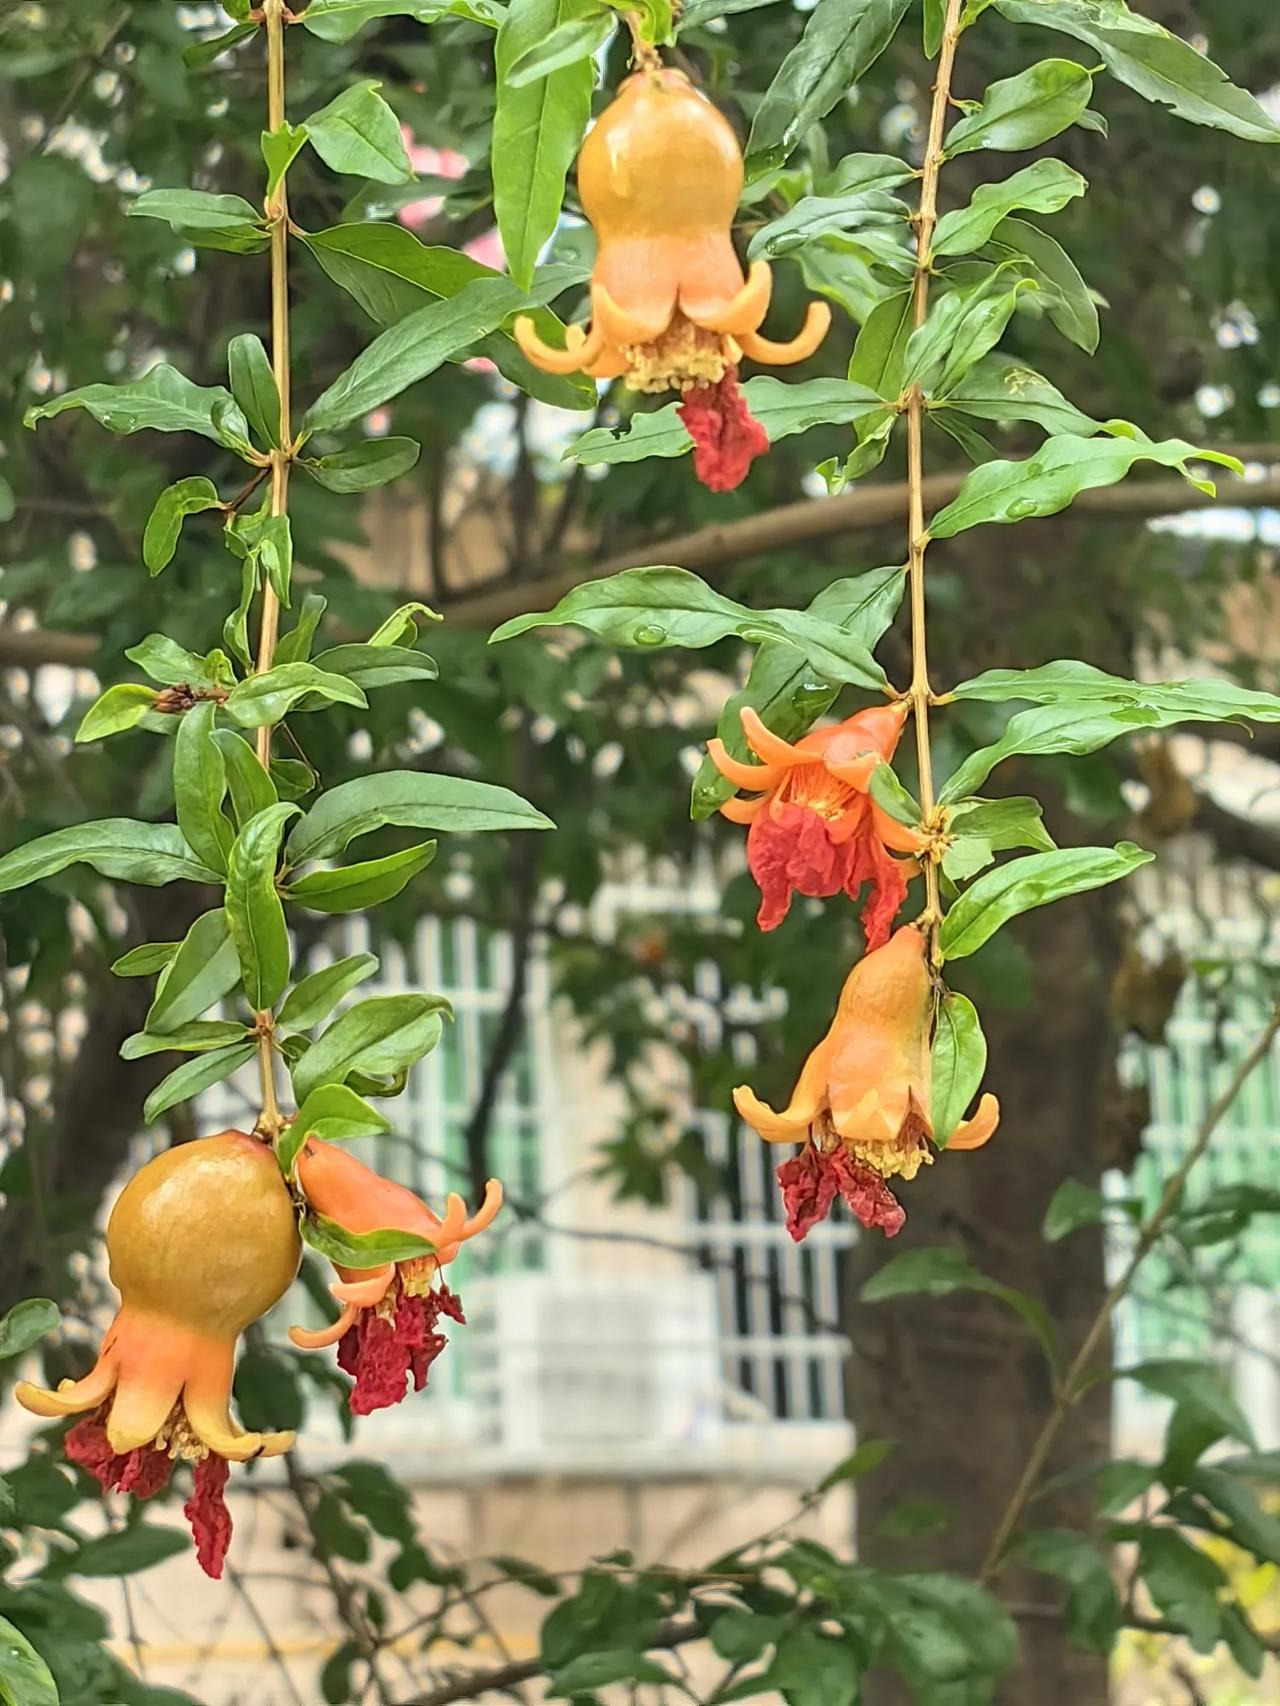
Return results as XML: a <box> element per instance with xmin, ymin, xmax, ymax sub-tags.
<box><xmin>515</xmin><ymin>67</ymin><xmax>831</xmax><ymax>491</ymax></box>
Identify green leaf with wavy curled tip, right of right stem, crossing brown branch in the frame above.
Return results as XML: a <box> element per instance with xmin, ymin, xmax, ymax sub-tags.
<box><xmin>928</xmin><ymin>433</ymin><xmax>1241</xmax><ymax>539</ymax></box>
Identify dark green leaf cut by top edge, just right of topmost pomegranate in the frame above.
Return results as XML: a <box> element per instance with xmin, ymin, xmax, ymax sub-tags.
<box><xmin>746</xmin><ymin>0</ymin><xmax>910</xmax><ymax>179</ymax></box>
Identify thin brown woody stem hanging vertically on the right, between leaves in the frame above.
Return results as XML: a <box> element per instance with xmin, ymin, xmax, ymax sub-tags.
<box><xmin>906</xmin><ymin>0</ymin><xmax>963</xmax><ymax>943</ymax></box>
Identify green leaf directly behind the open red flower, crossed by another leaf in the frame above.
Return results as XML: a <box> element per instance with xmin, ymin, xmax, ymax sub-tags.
<box><xmin>689</xmin><ymin>568</ymin><xmax>906</xmax><ymax>819</ymax></box>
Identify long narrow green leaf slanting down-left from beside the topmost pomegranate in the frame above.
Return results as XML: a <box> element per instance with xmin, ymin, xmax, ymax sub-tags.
<box><xmin>302</xmin><ymin>275</ymin><xmax>515</xmax><ymax>433</ymax></box>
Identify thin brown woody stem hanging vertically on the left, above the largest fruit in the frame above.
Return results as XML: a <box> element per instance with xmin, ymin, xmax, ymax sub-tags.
<box><xmin>258</xmin><ymin>0</ymin><xmax>294</xmax><ymax>1138</ymax></box>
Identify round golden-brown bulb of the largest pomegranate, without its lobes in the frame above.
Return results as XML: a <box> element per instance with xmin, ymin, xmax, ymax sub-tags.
<box><xmin>106</xmin><ymin>1131</ymin><xmax>302</xmax><ymax>1339</ymax></box>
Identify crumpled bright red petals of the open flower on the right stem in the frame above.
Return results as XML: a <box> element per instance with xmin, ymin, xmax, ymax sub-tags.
<box><xmin>748</xmin><ymin>798</ymin><xmax>906</xmax><ymax>952</ymax></box>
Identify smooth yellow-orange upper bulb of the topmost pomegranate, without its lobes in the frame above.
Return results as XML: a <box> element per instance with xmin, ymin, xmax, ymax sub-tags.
<box><xmin>579</xmin><ymin>67</ymin><xmax>742</xmax><ymax>242</ymax></box>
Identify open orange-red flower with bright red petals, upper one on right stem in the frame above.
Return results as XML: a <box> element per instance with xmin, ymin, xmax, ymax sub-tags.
<box><xmin>707</xmin><ymin>699</ymin><xmax>925</xmax><ymax>949</ymax></box>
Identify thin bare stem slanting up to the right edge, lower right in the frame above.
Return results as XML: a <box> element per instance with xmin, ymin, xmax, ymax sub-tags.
<box><xmin>978</xmin><ymin>1007</ymin><xmax>1280</xmax><ymax>1587</ymax></box>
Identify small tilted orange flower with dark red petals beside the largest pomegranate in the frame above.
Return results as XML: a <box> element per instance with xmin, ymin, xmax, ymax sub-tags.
<box><xmin>288</xmin><ymin>1138</ymin><xmax>502</xmax><ymax>1416</ymax></box>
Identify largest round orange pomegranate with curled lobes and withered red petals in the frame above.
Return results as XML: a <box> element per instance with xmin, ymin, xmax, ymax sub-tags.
<box><xmin>14</xmin><ymin>1131</ymin><xmax>300</xmax><ymax>1578</ymax></box>
